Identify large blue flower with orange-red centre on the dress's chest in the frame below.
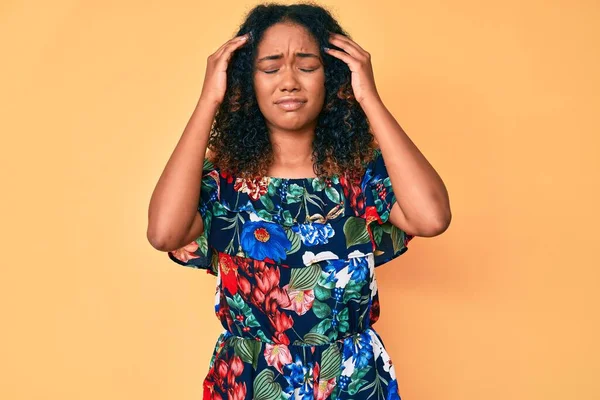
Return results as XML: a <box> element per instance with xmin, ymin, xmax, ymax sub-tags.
<box><xmin>240</xmin><ymin>221</ymin><xmax>292</xmax><ymax>262</ymax></box>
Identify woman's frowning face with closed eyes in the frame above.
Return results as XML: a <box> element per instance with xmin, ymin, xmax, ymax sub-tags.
<box><xmin>253</xmin><ymin>23</ymin><xmax>325</xmax><ymax>132</ymax></box>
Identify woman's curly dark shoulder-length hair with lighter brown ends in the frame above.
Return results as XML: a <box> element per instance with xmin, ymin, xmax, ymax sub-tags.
<box><xmin>208</xmin><ymin>2</ymin><xmax>376</xmax><ymax>180</ymax></box>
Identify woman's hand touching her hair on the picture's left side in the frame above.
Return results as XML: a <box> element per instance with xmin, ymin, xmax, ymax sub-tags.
<box><xmin>200</xmin><ymin>33</ymin><xmax>249</xmax><ymax>104</ymax></box>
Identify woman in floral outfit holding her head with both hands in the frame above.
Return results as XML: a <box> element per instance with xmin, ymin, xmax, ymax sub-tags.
<box><xmin>148</xmin><ymin>4</ymin><xmax>450</xmax><ymax>399</ymax></box>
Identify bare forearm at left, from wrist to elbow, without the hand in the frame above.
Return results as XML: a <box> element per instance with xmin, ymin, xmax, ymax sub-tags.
<box><xmin>146</xmin><ymin>97</ymin><xmax>218</xmax><ymax>251</ymax></box>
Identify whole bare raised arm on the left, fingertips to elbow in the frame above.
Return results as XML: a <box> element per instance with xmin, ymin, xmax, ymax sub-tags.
<box><xmin>146</xmin><ymin>34</ymin><xmax>250</xmax><ymax>251</ymax></box>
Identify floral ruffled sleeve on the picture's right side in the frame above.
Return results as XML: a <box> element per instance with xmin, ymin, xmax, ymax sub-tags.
<box><xmin>362</xmin><ymin>148</ymin><xmax>414</xmax><ymax>267</ymax></box>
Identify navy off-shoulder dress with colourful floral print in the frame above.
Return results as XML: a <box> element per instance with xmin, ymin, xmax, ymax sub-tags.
<box><xmin>168</xmin><ymin>149</ymin><xmax>413</xmax><ymax>400</ymax></box>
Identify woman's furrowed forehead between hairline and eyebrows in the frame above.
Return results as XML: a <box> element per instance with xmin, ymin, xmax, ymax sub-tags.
<box><xmin>258</xmin><ymin>23</ymin><xmax>319</xmax><ymax>55</ymax></box>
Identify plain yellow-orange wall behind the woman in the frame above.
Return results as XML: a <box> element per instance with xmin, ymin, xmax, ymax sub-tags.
<box><xmin>0</xmin><ymin>0</ymin><xmax>600</xmax><ymax>400</ymax></box>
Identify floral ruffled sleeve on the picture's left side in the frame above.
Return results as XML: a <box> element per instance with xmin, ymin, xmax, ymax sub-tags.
<box><xmin>168</xmin><ymin>159</ymin><xmax>220</xmax><ymax>276</ymax></box>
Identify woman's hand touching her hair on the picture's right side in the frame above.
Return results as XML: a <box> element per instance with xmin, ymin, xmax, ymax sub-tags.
<box><xmin>325</xmin><ymin>33</ymin><xmax>380</xmax><ymax>103</ymax></box>
